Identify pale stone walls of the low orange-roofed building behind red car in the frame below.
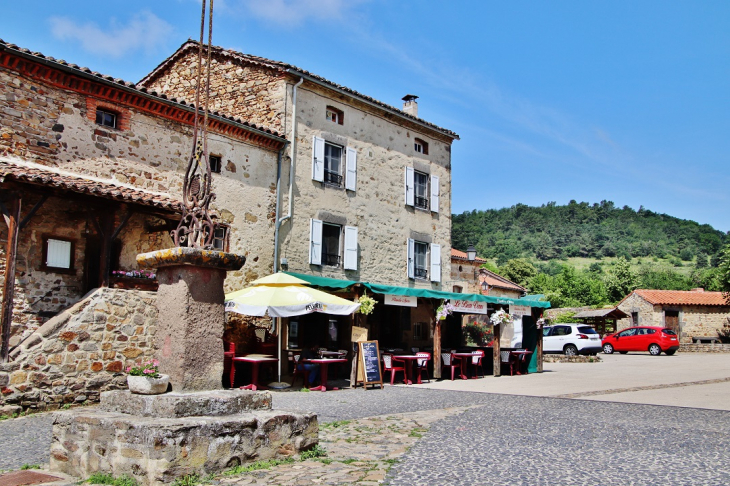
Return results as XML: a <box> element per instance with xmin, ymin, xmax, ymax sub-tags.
<box><xmin>618</xmin><ymin>293</ymin><xmax>730</xmax><ymax>343</ymax></box>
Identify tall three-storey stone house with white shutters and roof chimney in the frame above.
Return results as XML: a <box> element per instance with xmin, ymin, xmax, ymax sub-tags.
<box><xmin>140</xmin><ymin>42</ymin><xmax>458</xmax><ymax>360</ymax></box>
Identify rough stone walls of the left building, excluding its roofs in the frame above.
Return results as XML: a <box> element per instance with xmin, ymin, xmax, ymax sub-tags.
<box><xmin>0</xmin><ymin>44</ymin><xmax>284</xmax><ymax>342</ymax></box>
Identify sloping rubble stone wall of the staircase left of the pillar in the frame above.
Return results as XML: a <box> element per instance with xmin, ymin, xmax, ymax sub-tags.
<box><xmin>0</xmin><ymin>289</ymin><xmax>157</xmax><ymax>409</ymax></box>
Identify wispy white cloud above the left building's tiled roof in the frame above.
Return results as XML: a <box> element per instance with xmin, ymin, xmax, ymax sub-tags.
<box><xmin>49</xmin><ymin>12</ymin><xmax>173</xmax><ymax>58</ymax></box>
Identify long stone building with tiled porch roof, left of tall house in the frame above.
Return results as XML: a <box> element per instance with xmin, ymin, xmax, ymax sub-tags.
<box><xmin>0</xmin><ymin>42</ymin><xmax>287</xmax><ymax>408</ymax></box>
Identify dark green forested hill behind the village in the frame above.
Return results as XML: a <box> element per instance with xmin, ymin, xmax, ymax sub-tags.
<box><xmin>452</xmin><ymin>201</ymin><xmax>730</xmax><ymax>265</ymax></box>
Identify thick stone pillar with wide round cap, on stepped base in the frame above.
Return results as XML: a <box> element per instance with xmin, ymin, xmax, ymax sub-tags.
<box><xmin>137</xmin><ymin>248</ymin><xmax>246</xmax><ymax>392</ymax></box>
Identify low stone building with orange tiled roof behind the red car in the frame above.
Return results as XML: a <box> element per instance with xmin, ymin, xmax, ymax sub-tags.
<box><xmin>617</xmin><ymin>289</ymin><xmax>730</xmax><ymax>343</ymax></box>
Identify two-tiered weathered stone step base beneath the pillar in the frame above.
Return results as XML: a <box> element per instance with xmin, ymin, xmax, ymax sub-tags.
<box><xmin>51</xmin><ymin>391</ymin><xmax>319</xmax><ymax>485</ymax></box>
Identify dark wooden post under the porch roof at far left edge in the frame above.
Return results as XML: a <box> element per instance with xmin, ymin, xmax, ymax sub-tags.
<box><xmin>0</xmin><ymin>195</ymin><xmax>21</xmax><ymax>363</ymax></box>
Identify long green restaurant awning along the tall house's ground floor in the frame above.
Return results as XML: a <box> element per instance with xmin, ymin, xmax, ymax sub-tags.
<box><xmin>286</xmin><ymin>272</ymin><xmax>550</xmax><ymax>309</ymax></box>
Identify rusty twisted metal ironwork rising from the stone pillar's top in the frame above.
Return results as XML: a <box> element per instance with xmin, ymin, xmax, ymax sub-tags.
<box><xmin>170</xmin><ymin>0</ymin><xmax>218</xmax><ymax>250</ymax></box>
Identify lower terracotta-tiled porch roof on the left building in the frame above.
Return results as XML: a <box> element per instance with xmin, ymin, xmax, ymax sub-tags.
<box><xmin>0</xmin><ymin>158</ymin><xmax>181</xmax><ymax>212</ymax></box>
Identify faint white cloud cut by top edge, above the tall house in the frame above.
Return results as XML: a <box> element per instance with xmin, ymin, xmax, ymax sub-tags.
<box><xmin>236</xmin><ymin>0</ymin><xmax>367</xmax><ymax>26</ymax></box>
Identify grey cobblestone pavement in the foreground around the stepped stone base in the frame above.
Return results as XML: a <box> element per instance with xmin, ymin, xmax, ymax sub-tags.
<box><xmin>0</xmin><ymin>387</ymin><xmax>730</xmax><ymax>485</ymax></box>
